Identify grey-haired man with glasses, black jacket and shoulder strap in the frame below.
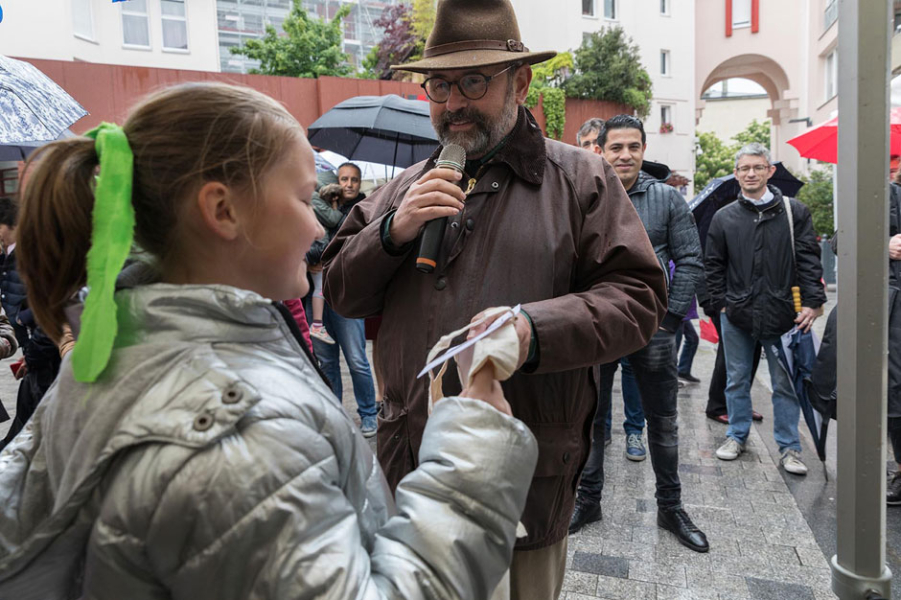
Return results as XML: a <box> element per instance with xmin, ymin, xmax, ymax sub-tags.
<box><xmin>705</xmin><ymin>143</ymin><xmax>826</xmax><ymax>475</ymax></box>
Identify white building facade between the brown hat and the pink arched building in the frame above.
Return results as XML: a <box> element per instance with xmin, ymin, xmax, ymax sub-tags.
<box><xmin>511</xmin><ymin>0</ymin><xmax>697</xmax><ymax>191</ymax></box>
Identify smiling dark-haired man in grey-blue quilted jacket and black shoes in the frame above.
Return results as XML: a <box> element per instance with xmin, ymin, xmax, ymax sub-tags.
<box><xmin>570</xmin><ymin>115</ymin><xmax>710</xmax><ymax>552</ymax></box>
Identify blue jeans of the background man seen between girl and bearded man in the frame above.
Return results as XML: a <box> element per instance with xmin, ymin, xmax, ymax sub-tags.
<box><xmin>313</xmin><ymin>304</ymin><xmax>377</xmax><ymax>418</ymax></box>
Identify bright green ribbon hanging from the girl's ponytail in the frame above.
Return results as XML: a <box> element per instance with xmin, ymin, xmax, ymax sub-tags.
<box><xmin>72</xmin><ymin>123</ymin><xmax>135</xmax><ymax>383</ymax></box>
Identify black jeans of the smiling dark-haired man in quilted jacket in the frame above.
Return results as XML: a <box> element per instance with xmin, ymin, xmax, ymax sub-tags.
<box><xmin>578</xmin><ymin>331</ymin><xmax>682</xmax><ymax>508</ymax></box>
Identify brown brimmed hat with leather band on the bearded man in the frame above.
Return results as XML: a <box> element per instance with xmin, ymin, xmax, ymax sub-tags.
<box><xmin>391</xmin><ymin>0</ymin><xmax>557</xmax><ymax>73</ymax></box>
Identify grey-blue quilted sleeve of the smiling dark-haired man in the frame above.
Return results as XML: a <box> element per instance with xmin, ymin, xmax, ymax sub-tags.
<box><xmin>662</xmin><ymin>189</ymin><xmax>704</xmax><ymax>331</ymax></box>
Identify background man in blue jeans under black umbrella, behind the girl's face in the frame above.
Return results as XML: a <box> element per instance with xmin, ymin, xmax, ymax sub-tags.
<box><xmin>313</xmin><ymin>162</ymin><xmax>378</xmax><ymax>437</ymax></box>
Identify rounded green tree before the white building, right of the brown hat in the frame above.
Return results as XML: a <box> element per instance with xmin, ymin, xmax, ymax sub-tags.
<box><xmin>564</xmin><ymin>27</ymin><xmax>651</xmax><ymax>117</ymax></box>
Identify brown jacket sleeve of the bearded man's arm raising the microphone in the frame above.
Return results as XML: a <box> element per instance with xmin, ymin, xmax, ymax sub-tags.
<box><xmin>322</xmin><ymin>166</ymin><xmax>419</xmax><ymax>318</ymax></box>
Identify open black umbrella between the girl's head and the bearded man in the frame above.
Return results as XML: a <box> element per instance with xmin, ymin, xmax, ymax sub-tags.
<box><xmin>309</xmin><ymin>95</ymin><xmax>438</xmax><ymax>167</ymax></box>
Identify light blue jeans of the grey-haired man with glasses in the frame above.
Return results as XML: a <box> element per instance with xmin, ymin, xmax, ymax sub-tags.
<box><xmin>720</xmin><ymin>313</ymin><xmax>801</xmax><ymax>453</ymax></box>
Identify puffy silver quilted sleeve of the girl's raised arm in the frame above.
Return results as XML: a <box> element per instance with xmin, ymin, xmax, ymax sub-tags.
<box><xmin>85</xmin><ymin>398</ymin><xmax>537</xmax><ymax>600</ymax></box>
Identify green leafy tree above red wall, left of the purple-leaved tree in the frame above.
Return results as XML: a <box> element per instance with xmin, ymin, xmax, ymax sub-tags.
<box><xmin>231</xmin><ymin>0</ymin><xmax>352</xmax><ymax>78</ymax></box>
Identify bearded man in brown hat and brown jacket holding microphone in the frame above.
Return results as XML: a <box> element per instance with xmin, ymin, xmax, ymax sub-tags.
<box><xmin>325</xmin><ymin>0</ymin><xmax>666</xmax><ymax>600</ymax></box>
